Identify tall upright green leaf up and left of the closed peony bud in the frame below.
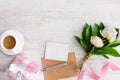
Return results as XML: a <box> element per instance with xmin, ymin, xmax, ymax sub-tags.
<box><xmin>82</xmin><ymin>23</ymin><xmax>92</xmax><ymax>44</ymax></box>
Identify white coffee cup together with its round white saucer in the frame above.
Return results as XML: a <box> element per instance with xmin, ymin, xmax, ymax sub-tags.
<box><xmin>0</xmin><ymin>30</ymin><xmax>24</xmax><ymax>55</ymax></box>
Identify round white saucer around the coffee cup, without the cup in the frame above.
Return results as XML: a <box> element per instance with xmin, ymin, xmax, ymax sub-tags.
<box><xmin>0</xmin><ymin>30</ymin><xmax>24</xmax><ymax>55</ymax></box>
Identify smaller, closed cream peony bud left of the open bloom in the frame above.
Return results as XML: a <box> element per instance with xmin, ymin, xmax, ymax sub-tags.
<box><xmin>90</xmin><ymin>36</ymin><xmax>104</xmax><ymax>48</ymax></box>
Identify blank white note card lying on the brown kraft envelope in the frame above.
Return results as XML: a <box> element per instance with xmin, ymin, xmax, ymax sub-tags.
<box><xmin>45</xmin><ymin>42</ymin><xmax>69</xmax><ymax>61</ymax></box>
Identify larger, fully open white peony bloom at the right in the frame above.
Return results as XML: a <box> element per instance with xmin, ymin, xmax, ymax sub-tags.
<box><xmin>101</xmin><ymin>27</ymin><xmax>117</xmax><ymax>43</ymax></box>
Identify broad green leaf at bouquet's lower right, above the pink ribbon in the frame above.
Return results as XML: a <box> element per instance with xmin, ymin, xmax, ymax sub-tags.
<box><xmin>100</xmin><ymin>46</ymin><xmax>120</xmax><ymax>57</ymax></box>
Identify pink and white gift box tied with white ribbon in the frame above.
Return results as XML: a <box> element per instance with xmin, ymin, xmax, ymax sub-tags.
<box><xmin>8</xmin><ymin>55</ymin><xmax>40</xmax><ymax>80</ymax></box>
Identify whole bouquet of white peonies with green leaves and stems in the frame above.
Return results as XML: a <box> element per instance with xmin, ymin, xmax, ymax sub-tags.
<box><xmin>75</xmin><ymin>22</ymin><xmax>120</xmax><ymax>72</ymax></box>
